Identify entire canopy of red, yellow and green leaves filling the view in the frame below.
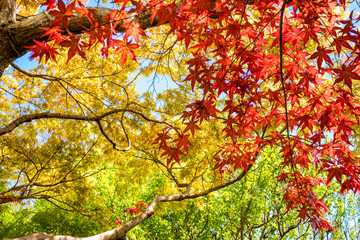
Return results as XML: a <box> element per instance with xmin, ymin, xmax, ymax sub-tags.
<box><xmin>0</xmin><ymin>0</ymin><xmax>360</xmax><ymax>239</ymax></box>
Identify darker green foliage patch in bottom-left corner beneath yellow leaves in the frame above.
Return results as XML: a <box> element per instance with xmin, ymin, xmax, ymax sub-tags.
<box><xmin>0</xmin><ymin>200</ymin><xmax>102</xmax><ymax>239</ymax></box>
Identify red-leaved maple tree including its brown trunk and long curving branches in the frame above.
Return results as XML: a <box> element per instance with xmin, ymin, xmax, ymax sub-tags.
<box><xmin>0</xmin><ymin>0</ymin><xmax>360</xmax><ymax>239</ymax></box>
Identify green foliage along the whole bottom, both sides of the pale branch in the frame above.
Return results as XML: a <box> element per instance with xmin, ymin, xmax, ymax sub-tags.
<box><xmin>0</xmin><ymin>147</ymin><xmax>360</xmax><ymax>240</ymax></box>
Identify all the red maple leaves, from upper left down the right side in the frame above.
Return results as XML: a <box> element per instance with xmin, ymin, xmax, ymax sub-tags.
<box><xmin>30</xmin><ymin>0</ymin><xmax>360</xmax><ymax>229</ymax></box>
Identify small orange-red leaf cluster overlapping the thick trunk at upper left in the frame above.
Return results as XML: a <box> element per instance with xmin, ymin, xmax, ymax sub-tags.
<box><xmin>27</xmin><ymin>0</ymin><xmax>146</xmax><ymax>66</ymax></box>
